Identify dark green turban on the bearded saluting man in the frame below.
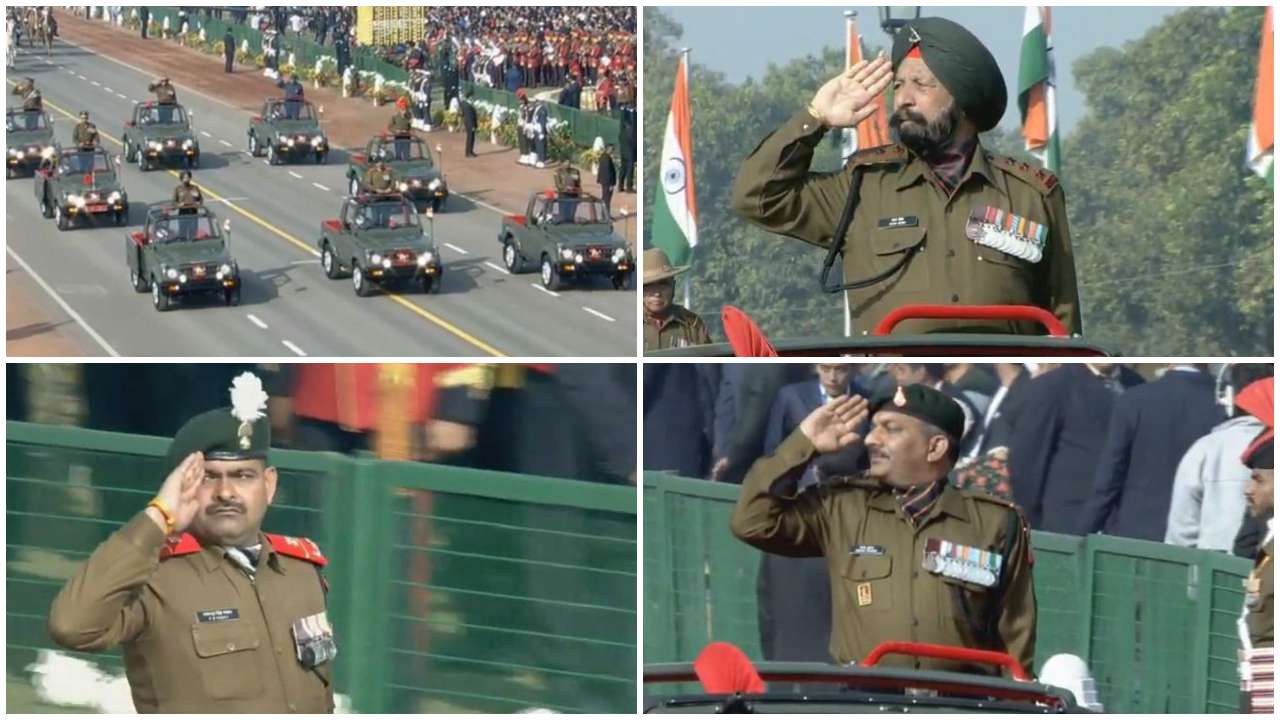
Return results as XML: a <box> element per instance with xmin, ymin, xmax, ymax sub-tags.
<box><xmin>892</xmin><ymin>18</ymin><xmax>1009</xmax><ymax>132</ymax></box>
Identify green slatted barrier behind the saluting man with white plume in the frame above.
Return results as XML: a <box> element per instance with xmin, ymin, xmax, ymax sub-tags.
<box><xmin>5</xmin><ymin>423</ymin><xmax>636</xmax><ymax>712</ymax></box>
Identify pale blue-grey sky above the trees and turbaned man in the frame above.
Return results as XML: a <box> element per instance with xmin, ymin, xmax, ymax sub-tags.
<box><xmin>660</xmin><ymin>5</ymin><xmax>1179</xmax><ymax>135</ymax></box>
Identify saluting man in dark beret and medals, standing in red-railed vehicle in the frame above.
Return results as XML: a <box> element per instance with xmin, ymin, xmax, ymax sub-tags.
<box><xmin>731</xmin><ymin>384</ymin><xmax>1036</xmax><ymax>674</ymax></box>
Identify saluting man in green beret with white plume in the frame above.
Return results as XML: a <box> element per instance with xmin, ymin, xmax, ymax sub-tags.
<box><xmin>49</xmin><ymin>373</ymin><xmax>337</xmax><ymax>714</ymax></box>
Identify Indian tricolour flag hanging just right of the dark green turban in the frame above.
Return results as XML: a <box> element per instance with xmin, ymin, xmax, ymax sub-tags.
<box><xmin>1018</xmin><ymin>6</ymin><xmax>1061</xmax><ymax>173</ymax></box>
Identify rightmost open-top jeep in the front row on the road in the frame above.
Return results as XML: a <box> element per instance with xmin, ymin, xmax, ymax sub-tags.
<box><xmin>498</xmin><ymin>190</ymin><xmax>635</xmax><ymax>291</ymax></box>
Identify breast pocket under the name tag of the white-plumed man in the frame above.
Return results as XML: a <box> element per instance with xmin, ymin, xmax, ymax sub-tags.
<box><xmin>191</xmin><ymin>620</ymin><xmax>262</xmax><ymax>700</ymax></box>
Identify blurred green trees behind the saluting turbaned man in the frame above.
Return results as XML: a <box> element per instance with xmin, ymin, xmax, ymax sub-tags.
<box><xmin>644</xmin><ymin>8</ymin><xmax>1275</xmax><ymax>356</ymax></box>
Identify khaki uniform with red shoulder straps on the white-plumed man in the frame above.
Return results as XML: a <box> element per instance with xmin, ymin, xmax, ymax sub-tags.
<box><xmin>49</xmin><ymin>512</ymin><xmax>334</xmax><ymax>714</ymax></box>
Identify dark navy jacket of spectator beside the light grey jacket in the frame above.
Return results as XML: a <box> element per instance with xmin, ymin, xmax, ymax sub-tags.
<box><xmin>1079</xmin><ymin>365</ymin><xmax>1224</xmax><ymax>542</ymax></box>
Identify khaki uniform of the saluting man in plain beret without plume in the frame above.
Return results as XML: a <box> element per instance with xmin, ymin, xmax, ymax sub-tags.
<box><xmin>731</xmin><ymin>429</ymin><xmax>1036</xmax><ymax>674</ymax></box>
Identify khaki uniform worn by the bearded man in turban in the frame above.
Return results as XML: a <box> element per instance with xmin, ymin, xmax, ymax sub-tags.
<box><xmin>733</xmin><ymin>110</ymin><xmax>1080</xmax><ymax>334</ymax></box>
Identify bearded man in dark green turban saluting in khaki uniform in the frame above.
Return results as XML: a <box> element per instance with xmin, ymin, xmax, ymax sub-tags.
<box><xmin>733</xmin><ymin>18</ymin><xmax>1080</xmax><ymax>334</ymax></box>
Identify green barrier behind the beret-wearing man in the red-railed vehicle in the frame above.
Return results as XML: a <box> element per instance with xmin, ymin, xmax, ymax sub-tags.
<box><xmin>644</xmin><ymin>473</ymin><xmax>1249</xmax><ymax>712</ymax></box>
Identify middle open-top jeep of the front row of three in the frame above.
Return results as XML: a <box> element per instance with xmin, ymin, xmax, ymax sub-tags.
<box><xmin>317</xmin><ymin>193</ymin><xmax>444</xmax><ymax>297</ymax></box>
